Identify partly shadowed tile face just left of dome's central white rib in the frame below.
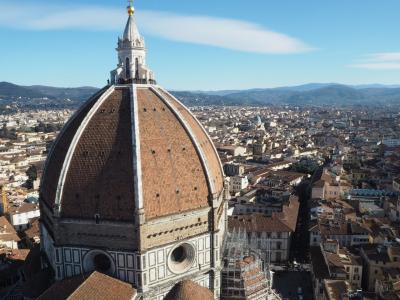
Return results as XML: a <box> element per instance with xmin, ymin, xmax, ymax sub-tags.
<box><xmin>61</xmin><ymin>88</ymin><xmax>135</xmax><ymax>221</ymax></box>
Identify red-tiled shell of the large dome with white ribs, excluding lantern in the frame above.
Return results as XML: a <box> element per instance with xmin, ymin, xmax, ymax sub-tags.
<box><xmin>41</xmin><ymin>84</ymin><xmax>223</xmax><ymax>222</ymax></box>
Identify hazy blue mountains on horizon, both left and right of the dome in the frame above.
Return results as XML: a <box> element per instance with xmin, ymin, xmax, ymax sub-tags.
<box><xmin>0</xmin><ymin>82</ymin><xmax>400</xmax><ymax>108</ymax></box>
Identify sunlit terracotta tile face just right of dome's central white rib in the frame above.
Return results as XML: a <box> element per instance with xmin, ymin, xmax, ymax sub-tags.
<box><xmin>137</xmin><ymin>88</ymin><xmax>210</xmax><ymax>219</ymax></box>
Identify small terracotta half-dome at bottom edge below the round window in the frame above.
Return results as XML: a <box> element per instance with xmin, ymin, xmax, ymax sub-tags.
<box><xmin>164</xmin><ymin>280</ymin><xmax>214</xmax><ymax>300</ymax></box>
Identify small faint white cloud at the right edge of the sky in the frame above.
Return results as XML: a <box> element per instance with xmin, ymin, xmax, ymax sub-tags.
<box><xmin>351</xmin><ymin>52</ymin><xmax>400</xmax><ymax>70</ymax></box>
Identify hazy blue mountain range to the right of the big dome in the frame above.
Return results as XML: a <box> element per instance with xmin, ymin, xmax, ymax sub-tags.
<box><xmin>173</xmin><ymin>83</ymin><xmax>400</xmax><ymax>106</ymax></box>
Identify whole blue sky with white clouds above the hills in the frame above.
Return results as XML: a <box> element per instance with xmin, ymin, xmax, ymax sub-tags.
<box><xmin>0</xmin><ymin>0</ymin><xmax>400</xmax><ymax>90</ymax></box>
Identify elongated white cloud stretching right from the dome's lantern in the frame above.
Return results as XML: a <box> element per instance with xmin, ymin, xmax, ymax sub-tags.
<box><xmin>139</xmin><ymin>12</ymin><xmax>311</xmax><ymax>53</ymax></box>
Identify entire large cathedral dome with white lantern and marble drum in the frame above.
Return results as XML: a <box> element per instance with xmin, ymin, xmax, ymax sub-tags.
<box><xmin>39</xmin><ymin>3</ymin><xmax>228</xmax><ymax>299</ymax></box>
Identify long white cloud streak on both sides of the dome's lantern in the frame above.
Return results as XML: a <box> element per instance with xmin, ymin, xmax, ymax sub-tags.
<box><xmin>0</xmin><ymin>1</ymin><xmax>313</xmax><ymax>54</ymax></box>
